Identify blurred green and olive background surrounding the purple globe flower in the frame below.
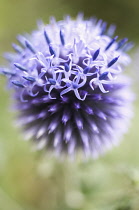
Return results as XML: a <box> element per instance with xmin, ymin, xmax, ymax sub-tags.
<box><xmin>0</xmin><ymin>0</ymin><xmax>139</xmax><ymax>210</ymax></box>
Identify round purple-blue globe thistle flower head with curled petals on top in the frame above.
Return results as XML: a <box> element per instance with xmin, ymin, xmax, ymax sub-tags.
<box><xmin>1</xmin><ymin>15</ymin><xmax>133</xmax><ymax>157</ymax></box>
